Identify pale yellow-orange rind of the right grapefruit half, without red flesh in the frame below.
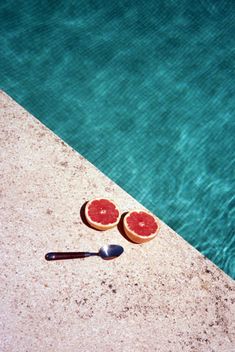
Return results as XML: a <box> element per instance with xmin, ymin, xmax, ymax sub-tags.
<box><xmin>123</xmin><ymin>209</ymin><xmax>160</xmax><ymax>244</ymax></box>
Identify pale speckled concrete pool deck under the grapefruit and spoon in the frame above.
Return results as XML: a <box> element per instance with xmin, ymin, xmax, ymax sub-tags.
<box><xmin>0</xmin><ymin>92</ymin><xmax>235</xmax><ymax>352</ymax></box>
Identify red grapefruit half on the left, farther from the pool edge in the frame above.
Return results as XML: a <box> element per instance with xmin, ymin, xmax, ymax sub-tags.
<box><xmin>85</xmin><ymin>198</ymin><xmax>121</xmax><ymax>230</ymax></box>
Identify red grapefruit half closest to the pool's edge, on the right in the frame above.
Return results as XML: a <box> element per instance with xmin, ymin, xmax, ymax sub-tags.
<box><xmin>123</xmin><ymin>210</ymin><xmax>160</xmax><ymax>243</ymax></box>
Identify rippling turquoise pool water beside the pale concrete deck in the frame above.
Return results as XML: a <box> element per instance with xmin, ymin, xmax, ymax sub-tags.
<box><xmin>0</xmin><ymin>0</ymin><xmax>235</xmax><ymax>277</ymax></box>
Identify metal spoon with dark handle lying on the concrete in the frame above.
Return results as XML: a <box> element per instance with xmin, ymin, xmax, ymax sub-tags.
<box><xmin>45</xmin><ymin>244</ymin><xmax>124</xmax><ymax>260</ymax></box>
